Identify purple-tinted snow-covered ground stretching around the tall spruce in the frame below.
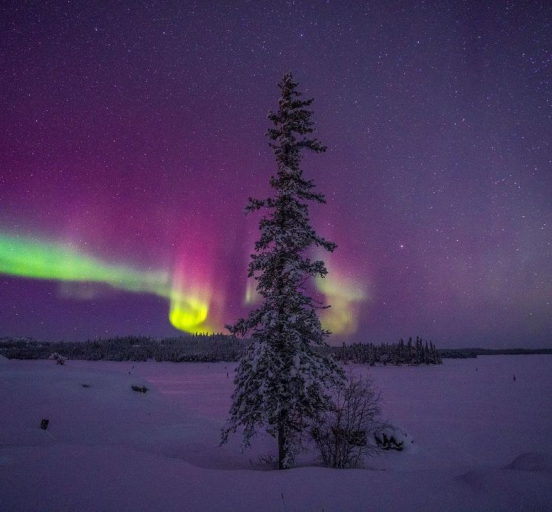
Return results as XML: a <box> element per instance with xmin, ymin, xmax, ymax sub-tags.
<box><xmin>0</xmin><ymin>355</ymin><xmax>552</xmax><ymax>512</ymax></box>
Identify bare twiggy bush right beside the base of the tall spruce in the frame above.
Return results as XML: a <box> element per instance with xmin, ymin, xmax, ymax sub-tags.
<box><xmin>311</xmin><ymin>376</ymin><xmax>385</xmax><ymax>468</ymax></box>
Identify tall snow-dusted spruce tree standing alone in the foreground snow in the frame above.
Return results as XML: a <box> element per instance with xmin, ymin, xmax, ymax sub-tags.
<box><xmin>222</xmin><ymin>74</ymin><xmax>344</xmax><ymax>469</ymax></box>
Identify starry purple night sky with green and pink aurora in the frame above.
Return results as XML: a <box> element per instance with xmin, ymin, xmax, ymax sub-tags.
<box><xmin>0</xmin><ymin>0</ymin><xmax>552</xmax><ymax>348</ymax></box>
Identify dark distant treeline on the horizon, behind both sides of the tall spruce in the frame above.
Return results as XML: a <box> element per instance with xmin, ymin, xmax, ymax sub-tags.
<box><xmin>0</xmin><ymin>334</ymin><xmax>441</xmax><ymax>365</ymax></box>
